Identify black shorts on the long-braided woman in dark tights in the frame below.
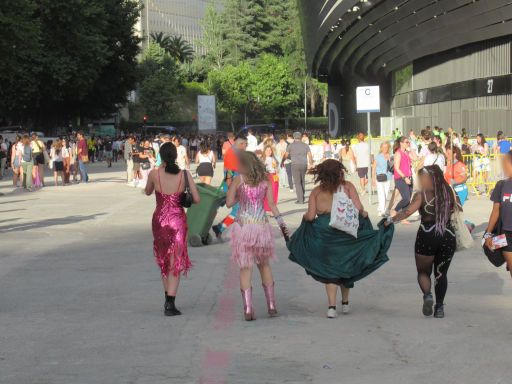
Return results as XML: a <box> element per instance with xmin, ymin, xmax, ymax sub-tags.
<box><xmin>414</xmin><ymin>223</ymin><xmax>457</xmax><ymax>256</ymax></box>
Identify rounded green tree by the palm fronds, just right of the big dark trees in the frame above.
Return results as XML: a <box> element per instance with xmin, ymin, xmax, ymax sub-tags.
<box><xmin>139</xmin><ymin>43</ymin><xmax>183</xmax><ymax>122</ymax></box>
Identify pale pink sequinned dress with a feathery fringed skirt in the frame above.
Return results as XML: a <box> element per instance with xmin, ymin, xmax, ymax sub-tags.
<box><xmin>231</xmin><ymin>178</ymin><xmax>276</xmax><ymax>268</ymax></box>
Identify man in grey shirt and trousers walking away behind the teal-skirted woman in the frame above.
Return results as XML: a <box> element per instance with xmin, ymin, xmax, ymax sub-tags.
<box><xmin>281</xmin><ymin>132</ymin><xmax>313</xmax><ymax>204</ymax></box>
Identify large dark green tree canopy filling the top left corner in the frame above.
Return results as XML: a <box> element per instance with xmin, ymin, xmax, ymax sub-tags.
<box><xmin>0</xmin><ymin>0</ymin><xmax>140</xmax><ymax>126</ymax></box>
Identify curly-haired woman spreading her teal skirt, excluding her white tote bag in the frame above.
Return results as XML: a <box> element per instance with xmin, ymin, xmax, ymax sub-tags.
<box><xmin>287</xmin><ymin>160</ymin><xmax>394</xmax><ymax>318</ymax></box>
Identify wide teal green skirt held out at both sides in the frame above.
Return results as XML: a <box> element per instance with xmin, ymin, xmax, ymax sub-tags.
<box><xmin>287</xmin><ymin>214</ymin><xmax>394</xmax><ymax>288</ymax></box>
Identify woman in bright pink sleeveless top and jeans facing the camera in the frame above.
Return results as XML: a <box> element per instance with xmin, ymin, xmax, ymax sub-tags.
<box><xmin>393</xmin><ymin>136</ymin><xmax>413</xmax><ymax>224</ymax></box>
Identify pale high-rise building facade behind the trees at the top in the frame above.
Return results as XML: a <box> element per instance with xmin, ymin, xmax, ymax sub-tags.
<box><xmin>138</xmin><ymin>0</ymin><xmax>221</xmax><ymax>54</ymax></box>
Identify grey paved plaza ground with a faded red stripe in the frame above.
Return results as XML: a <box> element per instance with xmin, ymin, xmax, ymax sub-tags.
<box><xmin>0</xmin><ymin>163</ymin><xmax>512</xmax><ymax>384</ymax></box>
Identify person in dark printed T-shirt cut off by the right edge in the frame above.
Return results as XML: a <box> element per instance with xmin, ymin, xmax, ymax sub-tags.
<box><xmin>484</xmin><ymin>151</ymin><xmax>512</xmax><ymax>276</ymax></box>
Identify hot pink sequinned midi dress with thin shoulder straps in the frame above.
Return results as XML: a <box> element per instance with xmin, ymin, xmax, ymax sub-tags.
<box><xmin>152</xmin><ymin>170</ymin><xmax>192</xmax><ymax>277</ymax></box>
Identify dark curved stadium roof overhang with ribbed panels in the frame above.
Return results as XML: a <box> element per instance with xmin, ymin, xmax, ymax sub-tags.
<box><xmin>299</xmin><ymin>0</ymin><xmax>512</xmax><ymax>79</ymax></box>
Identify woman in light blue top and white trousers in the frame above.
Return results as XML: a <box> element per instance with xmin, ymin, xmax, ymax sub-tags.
<box><xmin>372</xmin><ymin>141</ymin><xmax>393</xmax><ymax>217</ymax></box>
